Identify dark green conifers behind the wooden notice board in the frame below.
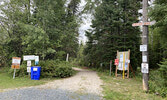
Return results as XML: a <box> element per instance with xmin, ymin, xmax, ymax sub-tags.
<box><xmin>84</xmin><ymin>0</ymin><xmax>140</xmax><ymax>70</ymax></box>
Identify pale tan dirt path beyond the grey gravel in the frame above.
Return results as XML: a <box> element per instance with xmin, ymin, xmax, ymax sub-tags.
<box><xmin>38</xmin><ymin>68</ymin><xmax>103</xmax><ymax>96</ymax></box>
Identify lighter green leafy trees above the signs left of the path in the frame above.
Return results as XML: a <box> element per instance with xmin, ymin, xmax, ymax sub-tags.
<box><xmin>0</xmin><ymin>0</ymin><xmax>80</xmax><ymax>65</ymax></box>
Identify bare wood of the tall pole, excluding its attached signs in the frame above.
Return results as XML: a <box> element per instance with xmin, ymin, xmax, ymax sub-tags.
<box><xmin>142</xmin><ymin>0</ymin><xmax>149</xmax><ymax>92</ymax></box>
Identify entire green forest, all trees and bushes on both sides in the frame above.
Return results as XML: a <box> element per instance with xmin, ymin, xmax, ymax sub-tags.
<box><xmin>0</xmin><ymin>0</ymin><xmax>167</xmax><ymax>97</ymax></box>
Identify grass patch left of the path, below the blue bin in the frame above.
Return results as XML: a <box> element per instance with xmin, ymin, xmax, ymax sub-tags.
<box><xmin>0</xmin><ymin>69</ymin><xmax>53</xmax><ymax>90</ymax></box>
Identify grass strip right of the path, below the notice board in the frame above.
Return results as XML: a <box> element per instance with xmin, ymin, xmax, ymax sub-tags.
<box><xmin>98</xmin><ymin>72</ymin><xmax>166</xmax><ymax>100</ymax></box>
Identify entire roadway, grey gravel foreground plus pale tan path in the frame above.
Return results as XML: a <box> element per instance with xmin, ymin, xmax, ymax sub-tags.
<box><xmin>0</xmin><ymin>68</ymin><xmax>103</xmax><ymax>100</ymax></box>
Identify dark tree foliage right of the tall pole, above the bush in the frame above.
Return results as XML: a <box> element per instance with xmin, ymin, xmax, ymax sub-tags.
<box><xmin>149</xmin><ymin>0</ymin><xmax>167</xmax><ymax>68</ymax></box>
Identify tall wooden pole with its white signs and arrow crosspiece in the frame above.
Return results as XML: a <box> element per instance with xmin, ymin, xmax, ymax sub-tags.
<box><xmin>132</xmin><ymin>0</ymin><xmax>150</xmax><ymax>92</ymax></box>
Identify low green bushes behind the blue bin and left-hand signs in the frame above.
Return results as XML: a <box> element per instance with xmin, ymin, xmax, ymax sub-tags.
<box><xmin>9</xmin><ymin>60</ymin><xmax>74</xmax><ymax>78</ymax></box>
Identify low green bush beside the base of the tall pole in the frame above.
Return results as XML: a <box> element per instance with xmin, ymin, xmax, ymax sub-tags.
<box><xmin>149</xmin><ymin>60</ymin><xmax>167</xmax><ymax>97</ymax></box>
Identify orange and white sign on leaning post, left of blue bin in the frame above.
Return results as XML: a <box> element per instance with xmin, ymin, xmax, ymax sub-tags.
<box><xmin>11</xmin><ymin>57</ymin><xmax>21</xmax><ymax>79</ymax></box>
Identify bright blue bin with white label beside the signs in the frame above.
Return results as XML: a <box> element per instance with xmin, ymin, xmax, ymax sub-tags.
<box><xmin>31</xmin><ymin>66</ymin><xmax>41</xmax><ymax>80</ymax></box>
